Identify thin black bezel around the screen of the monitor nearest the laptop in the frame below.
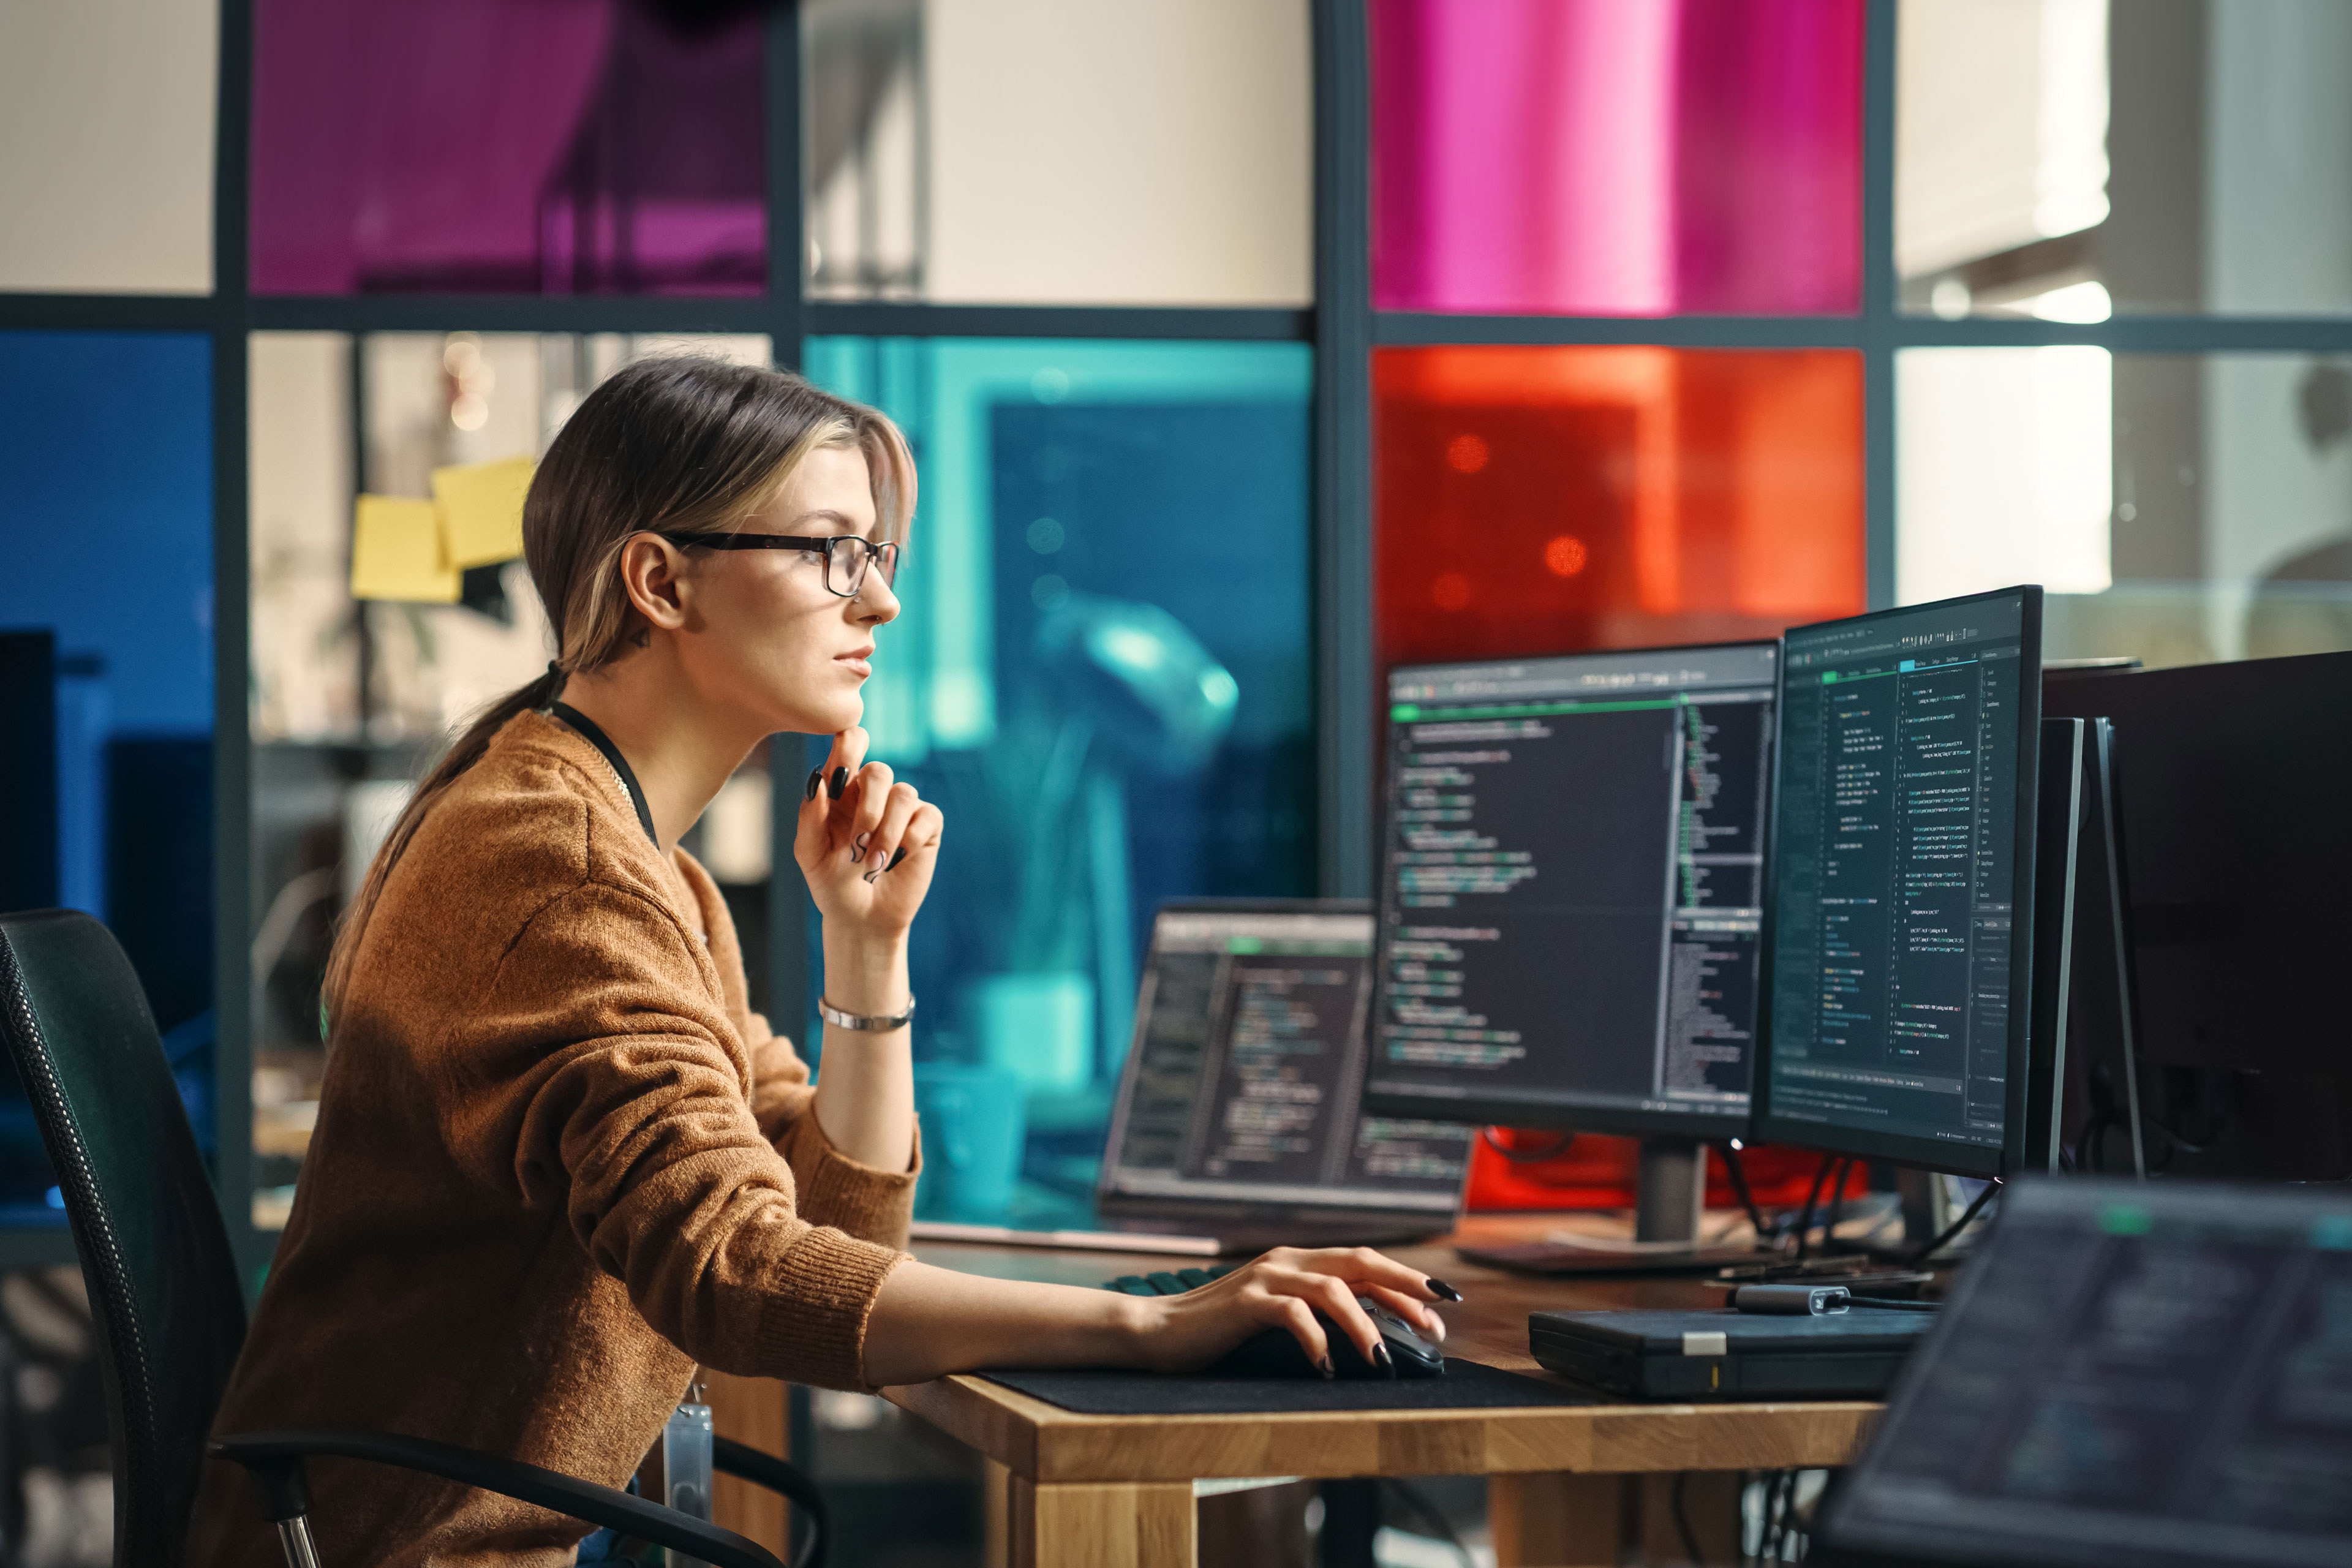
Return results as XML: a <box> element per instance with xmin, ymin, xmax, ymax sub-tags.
<box><xmin>1364</xmin><ymin>637</ymin><xmax>1787</xmax><ymax>1142</ymax></box>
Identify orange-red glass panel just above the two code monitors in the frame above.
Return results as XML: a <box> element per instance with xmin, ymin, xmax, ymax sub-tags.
<box><xmin>1374</xmin><ymin>345</ymin><xmax>1865</xmax><ymax>670</ymax></box>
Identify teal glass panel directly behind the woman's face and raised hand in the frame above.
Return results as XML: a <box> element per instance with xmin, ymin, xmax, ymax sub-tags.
<box><xmin>804</xmin><ymin>339</ymin><xmax>1315</xmax><ymax>1223</ymax></box>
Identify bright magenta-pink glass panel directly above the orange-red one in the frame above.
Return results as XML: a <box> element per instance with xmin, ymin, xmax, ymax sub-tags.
<box><xmin>1369</xmin><ymin>0</ymin><xmax>1863</xmax><ymax>315</ymax></box>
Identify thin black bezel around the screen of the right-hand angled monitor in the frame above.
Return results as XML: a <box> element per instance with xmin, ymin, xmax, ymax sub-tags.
<box><xmin>1747</xmin><ymin>583</ymin><xmax>2041</xmax><ymax>1180</ymax></box>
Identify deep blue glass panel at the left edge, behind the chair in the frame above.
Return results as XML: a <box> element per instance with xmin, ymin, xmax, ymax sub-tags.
<box><xmin>0</xmin><ymin>331</ymin><xmax>212</xmax><ymax>1225</ymax></box>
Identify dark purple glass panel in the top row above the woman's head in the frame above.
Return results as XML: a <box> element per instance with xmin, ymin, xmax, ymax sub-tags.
<box><xmin>252</xmin><ymin>0</ymin><xmax>767</xmax><ymax>294</ymax></box>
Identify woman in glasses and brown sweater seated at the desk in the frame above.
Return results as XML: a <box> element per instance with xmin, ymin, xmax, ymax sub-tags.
<box><xmin>190</xmin><ymin>360</ymin><xmax>1442</xmax><ymax>1568</ymax></box>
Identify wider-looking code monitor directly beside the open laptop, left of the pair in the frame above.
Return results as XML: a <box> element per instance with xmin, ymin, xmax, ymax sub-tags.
<box><xmin>1366</xmin><ymin>642</ymin><xmax>1778</xmax><ymax>1138</ymax></box>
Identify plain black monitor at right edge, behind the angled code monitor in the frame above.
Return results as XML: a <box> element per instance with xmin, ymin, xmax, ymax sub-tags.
<box><xmin>2044</xmin><ymin>654</ymin><xmax>2352</xmax><ymax>1178</ymax></box>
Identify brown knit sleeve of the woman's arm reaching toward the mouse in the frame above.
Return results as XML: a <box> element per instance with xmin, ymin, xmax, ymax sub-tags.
<box><xmin>445</xmin><ymin>881</ymin><xmax>903</xmax><ymax>1389</ymax></box>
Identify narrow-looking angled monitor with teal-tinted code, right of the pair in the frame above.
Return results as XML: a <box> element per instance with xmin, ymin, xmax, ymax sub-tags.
<box><xmin>1757</xmin><ymin>588</ymin><xmax>2041</xmax><ymax>1175</ymax></box>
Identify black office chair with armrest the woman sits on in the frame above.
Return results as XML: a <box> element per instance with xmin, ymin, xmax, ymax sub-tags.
<box><xmin>0</xmin><ymin>910</ymin><xmax>826</xmax><ymax>1568</ymax></box>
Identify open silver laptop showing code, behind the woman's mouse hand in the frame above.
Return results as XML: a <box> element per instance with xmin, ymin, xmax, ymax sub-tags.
<box><xmin>1103</xmin><ymin>905</ymin><xmax>1470</xmax><ymax>1215</ymax></box>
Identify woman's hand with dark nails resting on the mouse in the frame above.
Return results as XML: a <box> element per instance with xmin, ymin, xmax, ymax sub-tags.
<box><xmin>1129</xmin><ymin>1246</ymin><xmax>1447</xmax><ymax>1373</ymax></box>
